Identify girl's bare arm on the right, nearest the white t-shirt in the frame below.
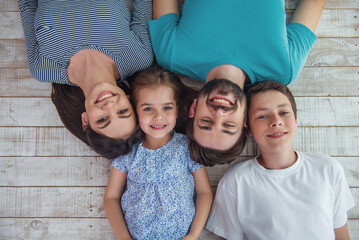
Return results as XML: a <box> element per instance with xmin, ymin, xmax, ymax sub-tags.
<box><xmin>182</xmin><ymin>167</ymin><xmax>213</xmax><ymax>240</ymax></box>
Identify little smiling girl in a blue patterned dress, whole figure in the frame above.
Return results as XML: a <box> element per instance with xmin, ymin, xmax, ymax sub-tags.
<box><xmin>104</xmin><ymin>66</ymin><xmax>212</xmax><ymax>239</ymax></box>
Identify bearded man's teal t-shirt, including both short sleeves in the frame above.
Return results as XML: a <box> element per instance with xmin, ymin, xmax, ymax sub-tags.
<box><xmin>148</xmin><ymin>0</ymin><xmax>317</xmax><ymax>84</ymax></box>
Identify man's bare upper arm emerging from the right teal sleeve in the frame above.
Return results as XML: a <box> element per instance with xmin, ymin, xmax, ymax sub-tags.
<box><xmin>291</xmin><ymin>0</ymin><xmax>326</xmax><ymax>33</ymax></box>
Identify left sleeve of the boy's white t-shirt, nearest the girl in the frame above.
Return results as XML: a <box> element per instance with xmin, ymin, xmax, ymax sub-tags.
<box><xmin>206</xmin><ymin>179</ymin><xmax>245</xmax><ymax>240</ymax></box>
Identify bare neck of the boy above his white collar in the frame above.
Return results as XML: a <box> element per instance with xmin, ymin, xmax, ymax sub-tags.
<box><xmin>257</xmin><ymin>148</ymin><xmax>298</xmax><ymax>170</ymax></box>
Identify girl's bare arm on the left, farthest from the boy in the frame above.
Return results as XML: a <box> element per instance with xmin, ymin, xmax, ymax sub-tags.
<box><xmin>103</xmin><ymin>167</ymin><xmax>132</xmax><ymax>239</ymax></box>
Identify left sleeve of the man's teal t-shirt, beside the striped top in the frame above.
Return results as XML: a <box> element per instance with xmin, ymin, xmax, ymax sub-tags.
<box><xmin>148</xmin><ymin>13</ymin><xmax>180</xmax><ymax>71</ymax></box>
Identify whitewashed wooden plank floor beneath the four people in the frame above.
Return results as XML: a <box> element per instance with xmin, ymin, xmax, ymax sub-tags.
<box><xmin>0</xmin><ymin>0</ymin><xmax>359</xmax><ymax>237</ymax></box>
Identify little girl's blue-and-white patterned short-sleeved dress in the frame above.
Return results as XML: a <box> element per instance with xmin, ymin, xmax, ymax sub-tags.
<box><xmin>111</xmin><ymin>133</ymin><xmax>202</xmax><ymax>240</ymax></box>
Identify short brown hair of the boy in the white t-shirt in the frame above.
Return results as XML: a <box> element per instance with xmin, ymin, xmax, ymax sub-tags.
<box><xmin>245</xmin><ymin>81</ymin><xmax>297</xmax><ymax>118</ymax></box>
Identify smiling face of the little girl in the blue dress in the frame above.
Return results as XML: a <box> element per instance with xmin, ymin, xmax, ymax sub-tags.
<box><xmin>136</xmin><ymin>85</ymin><xmax>177</xmax><ymax>144</ymax></box>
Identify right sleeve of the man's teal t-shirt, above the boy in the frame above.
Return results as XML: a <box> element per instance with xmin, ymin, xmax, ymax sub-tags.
<box><xmin>287</xmin><ymin>22</ymin><xmax>317</xmax><ymax>84</ymax></box>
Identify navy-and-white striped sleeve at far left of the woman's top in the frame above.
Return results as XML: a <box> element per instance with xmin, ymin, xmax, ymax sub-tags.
<box><xmin>18</xmin><ymin>0</ymin><xmax>64</xmax><ymax>83</ymax></box>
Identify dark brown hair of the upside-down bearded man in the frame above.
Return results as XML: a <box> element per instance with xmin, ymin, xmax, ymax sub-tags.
<box><xmin>186</xmin><ymin>118</ymin><xmax>247</xmax><ymax>167</ymax></box>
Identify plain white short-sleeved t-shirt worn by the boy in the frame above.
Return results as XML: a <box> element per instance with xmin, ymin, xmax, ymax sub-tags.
<box><xmin>206</xmin><ymin>152</ymin><xmax>354</xmax><ymax>240</ymax></box>
